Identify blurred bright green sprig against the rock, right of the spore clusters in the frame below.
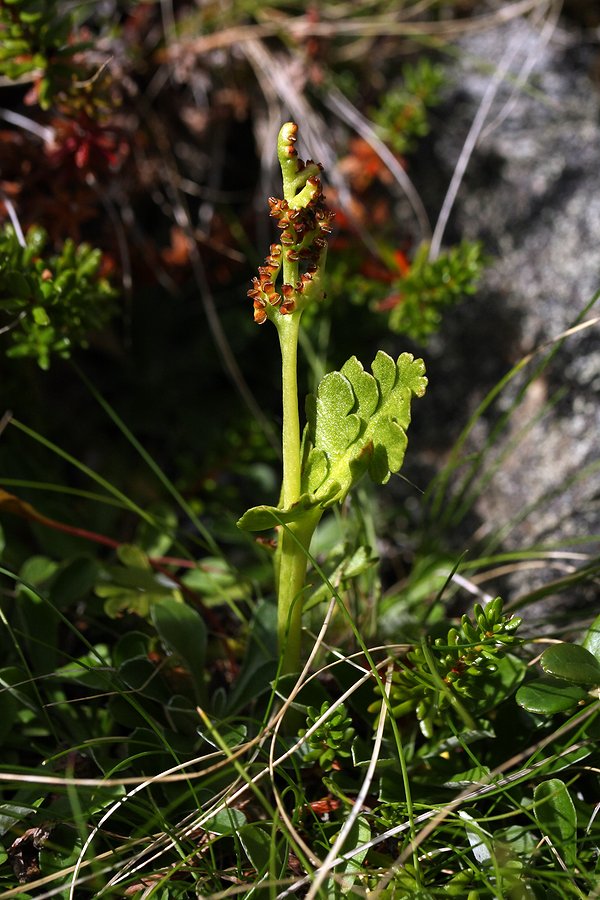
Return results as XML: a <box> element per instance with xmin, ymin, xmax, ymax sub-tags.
<box><xmin>380</xmin><ymin>241</ymin><xmax>484</xmax><ymax>342</ymax></box>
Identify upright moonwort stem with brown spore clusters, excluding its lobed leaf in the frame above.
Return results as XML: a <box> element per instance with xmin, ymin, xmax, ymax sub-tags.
<box><xmin>248</xmin><ymin>122</ymin><xmax>333</xmax><ymax>671</ymax></box>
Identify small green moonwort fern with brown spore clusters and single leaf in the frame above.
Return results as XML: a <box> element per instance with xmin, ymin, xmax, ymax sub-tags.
<box><xmin>238</xmin><ymin>122</ymin><xmax>427</xmax><ymax>672</ymax></box>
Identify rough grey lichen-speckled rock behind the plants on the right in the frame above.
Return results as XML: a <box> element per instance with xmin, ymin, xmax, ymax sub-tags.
<box><xmin>406</xmin><ymin>19</ymin><xmax>600</xmax><ymax>616</ymax></box>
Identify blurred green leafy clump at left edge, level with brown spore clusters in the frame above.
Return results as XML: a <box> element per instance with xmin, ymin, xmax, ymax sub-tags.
<box><xmin>0</xmin><ymin>225</ymin><xmax>117</xmax><ymax>369</ymax></box>
